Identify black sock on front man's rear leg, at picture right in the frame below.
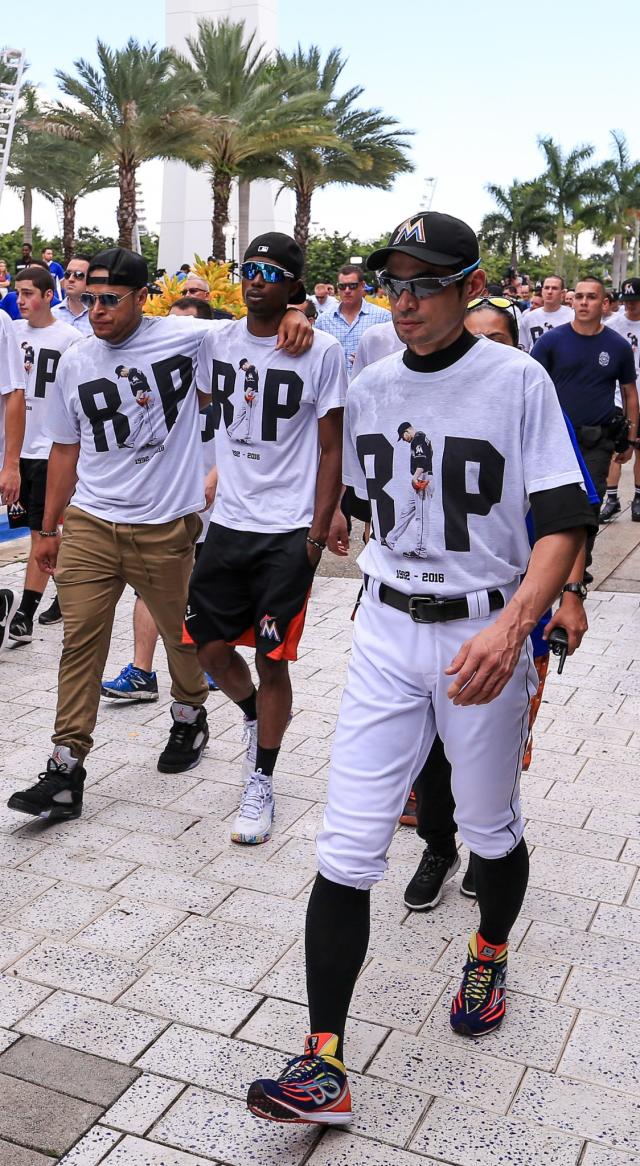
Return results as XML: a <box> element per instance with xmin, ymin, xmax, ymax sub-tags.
<box><xmin>473</xmin><ymin>838</ymin><xmax>529</xmax><ymax>946</ymax></box>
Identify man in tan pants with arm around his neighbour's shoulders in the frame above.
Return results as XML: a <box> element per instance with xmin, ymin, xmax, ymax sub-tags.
<box><xmin>8</xmin><ymin>247</ymin><xmax>311</xmax><ymax>819</ymax></box>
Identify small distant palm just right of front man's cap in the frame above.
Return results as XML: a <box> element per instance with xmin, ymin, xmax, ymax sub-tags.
<box><xmin>480</xmin><ymin>181</ymin><xmax>551</xmax><ymax>267</ymax></box>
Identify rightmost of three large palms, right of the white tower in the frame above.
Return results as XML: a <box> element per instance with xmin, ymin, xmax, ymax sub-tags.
<box><xmin>274</xmin><ymin>44</ymin><xmax>414</xmax><ymax>251</ymax></box>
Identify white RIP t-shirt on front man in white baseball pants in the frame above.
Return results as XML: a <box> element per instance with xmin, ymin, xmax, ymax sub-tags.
<box><xmin>343</xmin><ymin>337</ymin><xmax>584</xmax><ymax>597</ymax></box>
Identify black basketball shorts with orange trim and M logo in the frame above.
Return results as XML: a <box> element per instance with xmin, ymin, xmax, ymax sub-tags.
<box><xmin>185</xmin><ymin>522</ymin><xmax>315</xmax><ymax>660</ymax></box>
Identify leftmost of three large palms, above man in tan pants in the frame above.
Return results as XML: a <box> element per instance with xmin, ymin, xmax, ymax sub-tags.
<box><xmin>52</xmin><ymin>38</ymin><xmax>205</xmax><ymax>247</ymax></box>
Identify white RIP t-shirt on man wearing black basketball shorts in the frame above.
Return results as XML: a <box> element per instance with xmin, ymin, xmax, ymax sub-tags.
<box><xmin>198</xmin><ymin>319</ymin><xmax>346</xmax><ymax>533</ymax></box>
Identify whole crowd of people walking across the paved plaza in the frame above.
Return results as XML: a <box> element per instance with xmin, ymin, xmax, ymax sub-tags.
<box><xmin>0</xmin><ymin>212</ymin><xmax>640</xmax><ymax>1124</ymax></box>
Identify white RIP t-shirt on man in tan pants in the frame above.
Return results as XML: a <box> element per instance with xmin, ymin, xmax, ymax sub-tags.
<box><xmin>49</xmin><ymin>316</ymin><xmax>226</xmax><ymax>524</ymax></box>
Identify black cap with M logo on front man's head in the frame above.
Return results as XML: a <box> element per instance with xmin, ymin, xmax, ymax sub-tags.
<box><xmin>367</xmin><ymin>211</ymin><xmax>480</xmax><ymax>272</ymax></box>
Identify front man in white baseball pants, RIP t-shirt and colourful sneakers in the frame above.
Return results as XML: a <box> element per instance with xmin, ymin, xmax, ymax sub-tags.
<box><xmin>247</xmin><ymin>212</ymin><xmax>593</xmax><ymax>1124</ymax></box>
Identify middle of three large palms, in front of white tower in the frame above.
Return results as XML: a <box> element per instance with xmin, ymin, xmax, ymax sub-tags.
<box><xmin>176</xmin><ymin>20</ymin><xmax>335</xmax><ymax>259</ymax></box>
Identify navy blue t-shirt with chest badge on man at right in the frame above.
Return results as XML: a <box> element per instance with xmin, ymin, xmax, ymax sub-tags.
<box><xmin>532</xmin><ymin>324</ymin><xmax>635</xmax><ymax>426</ymax></box>
